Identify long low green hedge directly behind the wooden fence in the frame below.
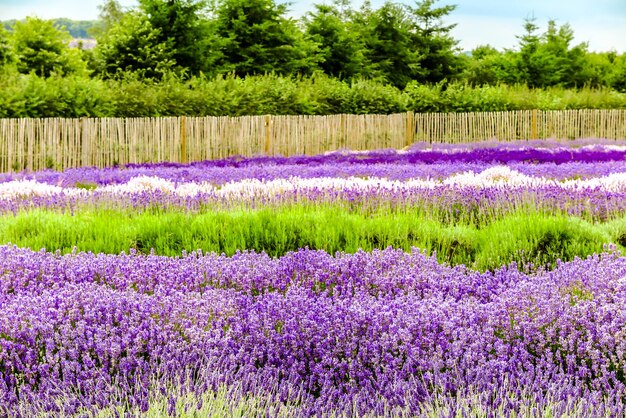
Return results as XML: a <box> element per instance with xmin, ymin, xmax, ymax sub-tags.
<box><xmin>0</xmin><ymin>72</ymin><xmax>626</xmax><ymax>117</ymax></box>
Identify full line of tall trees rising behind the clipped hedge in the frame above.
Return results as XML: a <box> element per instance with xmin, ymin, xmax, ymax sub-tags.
<box><xmin>0</xmin><ymin>0</ymin><xmax>626</xmax><ymax>92</ymax></box>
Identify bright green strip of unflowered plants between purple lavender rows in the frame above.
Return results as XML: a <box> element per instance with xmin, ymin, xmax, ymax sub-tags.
<box><xmin>0</xmin><ymin>206</ymin><xmax>626</xmax><ymax>271</ymax></box>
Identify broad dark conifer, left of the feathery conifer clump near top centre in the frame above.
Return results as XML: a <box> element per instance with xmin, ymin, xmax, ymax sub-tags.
<box><xmin>209</xmin><ymin>0</ymin><xmax>319</xmax><ymax>76</ymax></box>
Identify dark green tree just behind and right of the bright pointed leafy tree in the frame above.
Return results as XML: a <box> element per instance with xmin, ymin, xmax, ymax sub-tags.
<box><xmin>139</xmin><ymin>0</ymin><xmax>207</xmax><ymax>74</ymax></box>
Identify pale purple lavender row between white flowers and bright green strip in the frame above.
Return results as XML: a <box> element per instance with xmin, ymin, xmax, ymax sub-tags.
<box><xmin>0</xmin><ymin>185</ymin><xmax>626</xmax><ymax>221</ymax></box>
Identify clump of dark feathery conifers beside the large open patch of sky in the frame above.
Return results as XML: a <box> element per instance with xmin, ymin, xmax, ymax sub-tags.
<box><xmin>324</xmin><ymin>0</ymin><xmax>463</xmax><ymax>88</ymax></box>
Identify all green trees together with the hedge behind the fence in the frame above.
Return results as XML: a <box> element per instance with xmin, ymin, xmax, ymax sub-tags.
<box><xmin>0</xmin><ymin>0</ymin><xmax>626</xmax><ymax>115</ymax></box>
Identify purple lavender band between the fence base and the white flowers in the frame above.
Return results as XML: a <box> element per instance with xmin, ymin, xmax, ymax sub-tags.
<box><xmin>0</xmin><ymin>147</ymin><xmax>626</xmax><ymax>187</ymax></box>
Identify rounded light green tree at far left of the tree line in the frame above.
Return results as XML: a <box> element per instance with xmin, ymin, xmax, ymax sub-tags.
<box><xmin>12</xmin><ymin>17</ymin><xmax>87</xmax><ymax>77</ymax></box>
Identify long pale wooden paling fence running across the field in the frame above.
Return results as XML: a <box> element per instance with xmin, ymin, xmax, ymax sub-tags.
<box><xmin>0</xmin><ymin>110</ymin><xmax>626</xmax><ymax>172</ymax></box>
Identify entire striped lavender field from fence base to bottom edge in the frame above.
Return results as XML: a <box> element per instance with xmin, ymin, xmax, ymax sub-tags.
<box><xmin>0</xmin><ymin>141</ymin><xmax>626</xmax><ymax>417</ymax></box>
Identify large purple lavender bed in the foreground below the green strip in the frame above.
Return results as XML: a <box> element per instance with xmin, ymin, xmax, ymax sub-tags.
<box><xmin>0</xmin><ymin>247</ymin><xmax>626</xmax><ymax>415</ymax></box>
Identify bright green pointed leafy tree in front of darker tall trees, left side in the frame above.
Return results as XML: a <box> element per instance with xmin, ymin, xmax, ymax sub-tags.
<box><xmin>95</xmin><ymin>11</ymin><xmax>176</xmax><ymax>79</ymax></box>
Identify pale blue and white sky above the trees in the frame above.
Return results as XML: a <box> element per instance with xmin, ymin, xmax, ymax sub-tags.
<box><xmin>0</xmin><ymin>0</ymin><xmax>626</xmax><ymax>53</ymax></box>
